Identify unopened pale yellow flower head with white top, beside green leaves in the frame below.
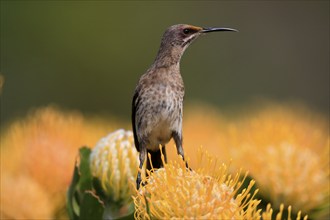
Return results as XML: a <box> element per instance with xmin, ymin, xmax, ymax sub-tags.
<box><xmin>90</xmin><ymin>129</ymin><xmax>138</xmax><ymax>205</ymax></box>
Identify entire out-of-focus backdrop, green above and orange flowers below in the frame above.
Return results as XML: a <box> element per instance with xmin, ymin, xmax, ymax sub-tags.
<box><xmin>0</xmin><ymin>0</ymin><xmax>330</xmax><ymax>219</ymax></box>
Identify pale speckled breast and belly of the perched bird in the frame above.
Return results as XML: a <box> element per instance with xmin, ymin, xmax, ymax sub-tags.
<box><xmin>137</xmin><ymin>84</ymin><xmax>183</xmax><ymax>150</ymax></box>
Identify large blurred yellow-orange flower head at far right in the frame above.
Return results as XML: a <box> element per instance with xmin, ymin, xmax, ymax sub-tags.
<box><xmin>228</xmin><ymin>106</ymin><xmax>330</xmax><ymax>216</ymax></box>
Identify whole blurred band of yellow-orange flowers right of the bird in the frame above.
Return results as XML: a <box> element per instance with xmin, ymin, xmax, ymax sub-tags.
<box><xmin>174</xmin><ymin>103</ymin><xmax>329</xmax><ymax>217</ymax></box>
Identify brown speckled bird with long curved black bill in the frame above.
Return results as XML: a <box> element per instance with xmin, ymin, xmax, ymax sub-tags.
<box><xmin>131</xmin><ymin>24</ymin><xmax>237</xmax><ymax>189</ymax></box>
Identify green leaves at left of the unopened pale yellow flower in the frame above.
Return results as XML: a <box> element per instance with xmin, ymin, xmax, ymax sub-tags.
<box><xmin>67</xmin><ymin>147</ymin><xmax>134</xmax><ymax>220</ymax></box>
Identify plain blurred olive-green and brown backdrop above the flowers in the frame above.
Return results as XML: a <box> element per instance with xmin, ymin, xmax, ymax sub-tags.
<box><xmin>0</xmin><ymin>1</ymin><xmax>329</xmax><ymax>123</ymax></box>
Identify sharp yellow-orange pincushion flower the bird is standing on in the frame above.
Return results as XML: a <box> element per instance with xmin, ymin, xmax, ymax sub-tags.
<box><xmin>134</xmin><ymin>149</ymin><xmax>260</xmax><ymax>219</ymax></box>
